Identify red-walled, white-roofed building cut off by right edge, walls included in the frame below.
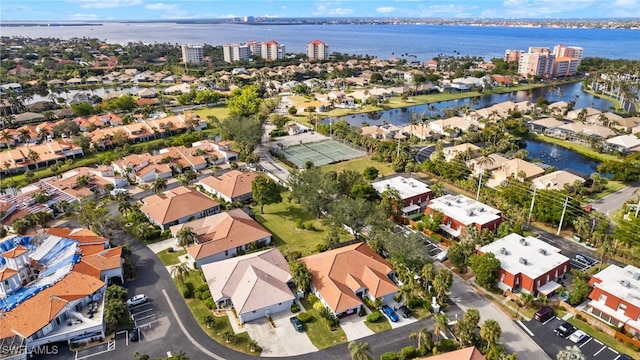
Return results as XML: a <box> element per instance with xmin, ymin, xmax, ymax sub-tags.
<box><xmin>586</xmin><ymin>265</ymin><xmax>640</xmax><ymax>334</ymax></box>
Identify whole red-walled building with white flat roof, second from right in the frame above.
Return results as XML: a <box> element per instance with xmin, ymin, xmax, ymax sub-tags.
<box><xmin>479</xmin><ymin>234</ymin><xmax>571</xmax><ymax>296</ymax></box>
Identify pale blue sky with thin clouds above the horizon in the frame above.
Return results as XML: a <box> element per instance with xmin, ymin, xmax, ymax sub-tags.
<box><xmin>0</xmin><ymin>0</ymin><xmax>640</xmax><ymax>21</ymax></box>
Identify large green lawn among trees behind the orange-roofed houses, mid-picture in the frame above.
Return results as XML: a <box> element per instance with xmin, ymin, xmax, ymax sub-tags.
<box><xmin>253</xmin><ymin>192</ymin><xmax>352</xmax><ymax>256</ymax></box>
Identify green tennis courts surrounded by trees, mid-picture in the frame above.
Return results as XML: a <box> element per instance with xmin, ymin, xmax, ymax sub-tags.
<box><xmin>276</xmin><ymin>140</ymin><xmax>364</xmax><ymax>168</ymax></box>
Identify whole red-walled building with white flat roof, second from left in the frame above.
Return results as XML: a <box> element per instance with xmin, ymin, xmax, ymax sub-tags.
<box><xmin>425</xmin><ymin>194</ymin><xmax>502</xmax><ymax>238</ymax></box>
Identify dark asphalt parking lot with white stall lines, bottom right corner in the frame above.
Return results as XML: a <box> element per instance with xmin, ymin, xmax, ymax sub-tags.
<box><xmin>523</xmin><ymin>317</ymin><xmax>620</xmax><ymax>360</ymax></box>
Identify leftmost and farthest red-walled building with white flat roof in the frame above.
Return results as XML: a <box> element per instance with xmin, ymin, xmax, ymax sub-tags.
<box><xmin>371</xmin><ymin>176</ymin><xmax>433</xmax><ymax>216</ymax></box>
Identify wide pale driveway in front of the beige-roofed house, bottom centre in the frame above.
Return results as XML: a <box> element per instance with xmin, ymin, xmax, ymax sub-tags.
<box><xmin>244</xmin><ymin>304</ymin><xmax>318</xmax><ymax>357</ymax></box>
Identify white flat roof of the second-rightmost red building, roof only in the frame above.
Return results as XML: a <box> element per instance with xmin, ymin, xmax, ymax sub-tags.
<box><xmin>480</xmin><ymin>234</ymin><xmax>569</xmax><ymax>279</ymax></box>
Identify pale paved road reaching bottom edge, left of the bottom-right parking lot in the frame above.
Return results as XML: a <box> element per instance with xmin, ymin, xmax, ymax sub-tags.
<box><xmin>449</xmin><ymin>275</ymin><xmax>550</xmax><ymax>360</ymax></box>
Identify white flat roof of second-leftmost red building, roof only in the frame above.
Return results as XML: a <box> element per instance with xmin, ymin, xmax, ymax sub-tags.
<box><xmin>429</xmin><ymin>194</ymin><xmax>501</xmax><ymax>226</ymax></box>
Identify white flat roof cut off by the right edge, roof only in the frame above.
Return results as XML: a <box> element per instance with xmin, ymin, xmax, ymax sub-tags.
<box><xmin>593</xmin><ymin>265</ymin><xmax>640</xmax><ymax>308</ymax></box>
